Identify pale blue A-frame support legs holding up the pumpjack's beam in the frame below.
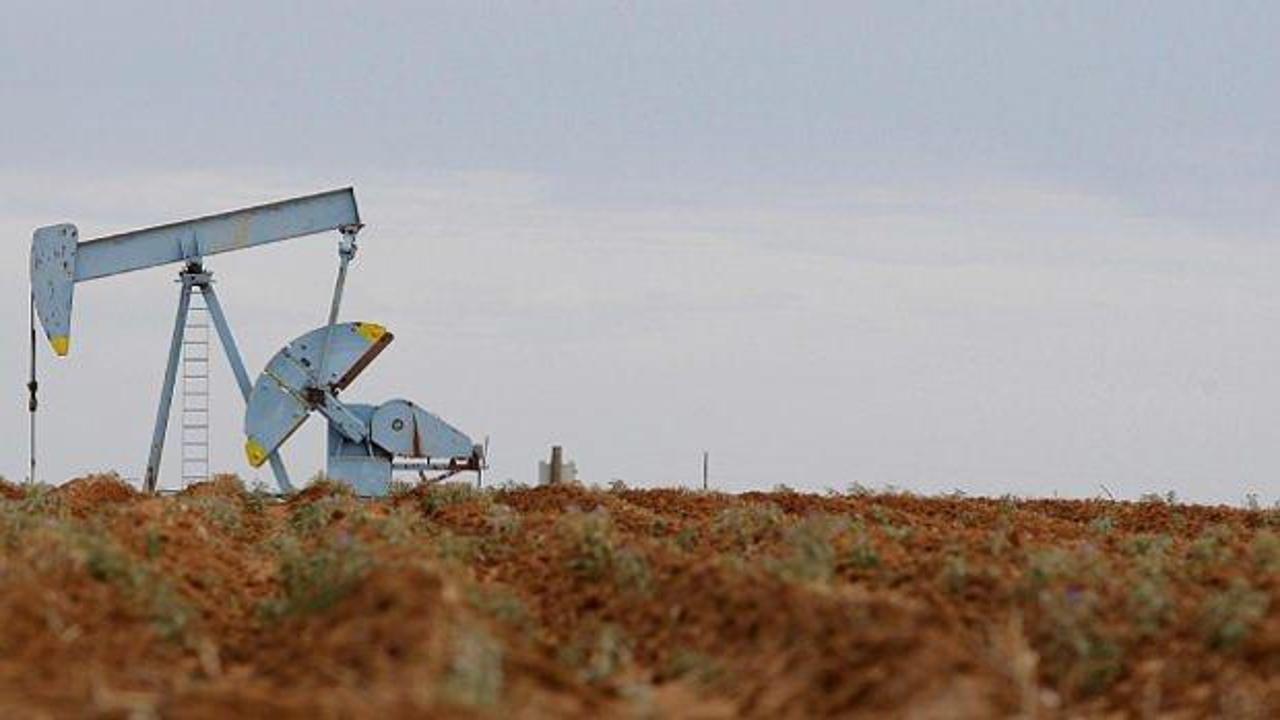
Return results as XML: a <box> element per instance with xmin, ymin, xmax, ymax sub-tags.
<box><xmin>142</xmin><ymin>260</ymin><xmax>293</xmax><ymax>493</ymax></box>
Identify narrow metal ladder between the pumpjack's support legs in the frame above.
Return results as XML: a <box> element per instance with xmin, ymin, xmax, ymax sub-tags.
<box><xmin>182</xmin><ymin>292</ymin><xmax>210</xmax><ymax>488</ymax></box>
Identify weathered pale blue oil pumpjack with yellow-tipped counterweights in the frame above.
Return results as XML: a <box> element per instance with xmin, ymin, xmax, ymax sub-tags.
<box><xmin>28</xmin><ymin>187</ymin><xmax>485</xmax><ymax>496</ymax></box>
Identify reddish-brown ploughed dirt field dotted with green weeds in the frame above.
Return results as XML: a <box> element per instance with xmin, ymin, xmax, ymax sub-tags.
<box><xmin>0</xmin><ymin>477</ymin><xmax>1280</xmax><ymax>717</ymax></box>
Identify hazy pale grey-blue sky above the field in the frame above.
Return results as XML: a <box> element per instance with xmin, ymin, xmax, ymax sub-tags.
<box><xmin>0</xmin><ymin>0</ymin><xmax>1280</xmax><ymax>502</ymax></box>
